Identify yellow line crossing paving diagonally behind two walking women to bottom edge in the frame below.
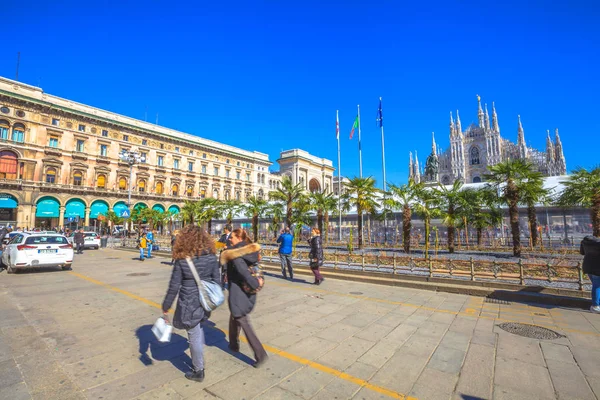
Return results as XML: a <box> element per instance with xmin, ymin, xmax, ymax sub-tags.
<box><xmin>69</xmin><ymin>272</ymin><xmax>418</xmax><ymax>400</ymax></box>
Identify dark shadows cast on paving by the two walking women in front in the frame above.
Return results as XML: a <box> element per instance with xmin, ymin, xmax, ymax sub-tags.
<box><xmin>135</xmin><ymin>321</ymin><xmax>254</xmax><ymax>372</ymax></box>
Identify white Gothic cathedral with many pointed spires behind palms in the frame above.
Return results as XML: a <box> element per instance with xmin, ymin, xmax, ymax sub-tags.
<box><xmin>409</xmin><ymin>96</ymin><xmax>567</xmax><ymax>185</ymax></box>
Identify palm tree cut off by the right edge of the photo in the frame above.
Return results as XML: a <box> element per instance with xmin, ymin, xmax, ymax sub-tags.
<box><xmin>558</xmin><ymin>166</ymin><xmax>600</xmax><ymax>237</ymax></box>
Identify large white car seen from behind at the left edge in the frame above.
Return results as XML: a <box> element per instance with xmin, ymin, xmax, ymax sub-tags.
<box><xmin>2</xmin><ymin>232</ymin><xmax>73</xmax><ymax>274</ymax></box>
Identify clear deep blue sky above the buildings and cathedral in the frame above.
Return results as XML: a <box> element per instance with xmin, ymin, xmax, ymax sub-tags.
<box><xmin>0</xmin><ymin>0</ymin><xmax>600</xmax><ymax>183</ymax></box>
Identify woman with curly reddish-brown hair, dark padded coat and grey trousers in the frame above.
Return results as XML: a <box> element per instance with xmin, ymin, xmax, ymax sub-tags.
<box><xmin>162</xmin><ymin>225</ymin><xmax>220</xmax><ymax>382</ymax></box>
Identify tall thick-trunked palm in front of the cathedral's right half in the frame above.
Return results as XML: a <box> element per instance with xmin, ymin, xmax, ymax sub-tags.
<box><xmin>485</xmin><ymin>160</ymin><xmax>533</xmax><ymax>257</ymax></box>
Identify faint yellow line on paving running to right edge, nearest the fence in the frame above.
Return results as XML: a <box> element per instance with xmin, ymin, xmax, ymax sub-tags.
<box><xmin>269</xmin><ymin>281</ymin><xmax>600</xmax><ymax>337</ymax></box>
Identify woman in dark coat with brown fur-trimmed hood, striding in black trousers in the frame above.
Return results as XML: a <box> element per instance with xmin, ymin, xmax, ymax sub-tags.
<box><xmin>220</xmin><ymin>229</ymin><xmax>269</xmax><ymax>368</ymax></box>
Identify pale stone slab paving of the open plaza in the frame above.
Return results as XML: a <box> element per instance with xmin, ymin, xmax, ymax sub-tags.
<box><xmin>0</xmin><ymin>249</ymin><xmax>600</xmax><ymax>400</ymax></box>
